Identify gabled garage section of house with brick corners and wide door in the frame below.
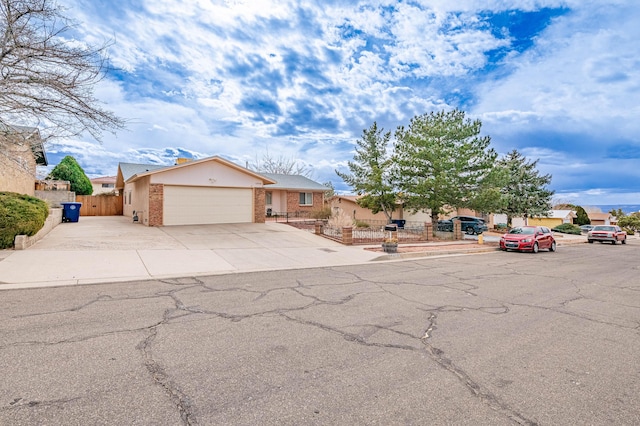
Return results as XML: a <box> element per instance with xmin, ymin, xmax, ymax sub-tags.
<box><xmin>116</xmin><ymin>156</ymin><xmax>275</xmax><ymax>226</ymax></box>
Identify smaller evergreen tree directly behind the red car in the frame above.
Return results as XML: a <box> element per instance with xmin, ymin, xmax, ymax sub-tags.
<box><xmin>495</xmin><ymin>149</ymin><xmax>554</xmax><ymax>226</ymax></box>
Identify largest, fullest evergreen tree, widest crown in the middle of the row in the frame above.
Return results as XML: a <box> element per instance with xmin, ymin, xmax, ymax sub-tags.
<box><xmin>394</xmin><ymin>110</ymin><xmax>497</xmax><ymax>232</ymax></box>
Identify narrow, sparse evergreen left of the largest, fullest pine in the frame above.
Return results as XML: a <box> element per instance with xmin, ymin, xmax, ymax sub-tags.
<box><xmin>336</xmin><ymin>122</ymin><xmax>397</xmax><ymax>221</ymax></box>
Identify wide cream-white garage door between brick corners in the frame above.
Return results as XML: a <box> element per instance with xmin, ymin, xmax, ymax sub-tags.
<box><xmin>163</xmin><ymin>185</ymin><xmax>253</xmax><ymax>225</ymax></box>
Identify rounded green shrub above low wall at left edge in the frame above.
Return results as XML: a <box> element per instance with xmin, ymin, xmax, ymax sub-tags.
<box><xmin>0</xmin><ymin>192</ymin><xmax>49</xmax><ymax>249</ymax></box>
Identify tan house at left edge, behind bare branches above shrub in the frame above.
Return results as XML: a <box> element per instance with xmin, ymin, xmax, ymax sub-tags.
<box><xmin>0</xmin><ymin>125</ymin><xmax>48</xmax><ymax>195</ymax></box>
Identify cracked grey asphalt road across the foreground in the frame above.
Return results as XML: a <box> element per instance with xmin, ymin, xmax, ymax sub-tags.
<box><xmin>0</xmin><ymin>240</ymin><xmax>640</xmax><ymax>425</ymax></box>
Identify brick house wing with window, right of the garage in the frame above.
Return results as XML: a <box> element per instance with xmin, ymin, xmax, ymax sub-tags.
<box><xmin>260</xmin><ymin>173</ymin><xmax>328</xmax><ymax>216</ymax></box>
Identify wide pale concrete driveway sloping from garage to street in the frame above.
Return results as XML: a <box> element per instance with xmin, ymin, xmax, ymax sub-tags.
<box><xmin>0</xmin><ymin>216</ymin><xmax>380</xmax><ymax>289</ymax></box>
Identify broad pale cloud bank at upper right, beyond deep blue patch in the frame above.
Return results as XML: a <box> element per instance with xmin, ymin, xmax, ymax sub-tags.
<box><xmin>474</xmin><ymin>0</ymin><xmax>640</xmax><ymax>137</ymax></box>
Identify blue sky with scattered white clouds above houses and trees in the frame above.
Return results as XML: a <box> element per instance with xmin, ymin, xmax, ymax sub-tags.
<box><xmin>42</xmin><ymin>0</ymin><xmax>640</xmax><ymax>205</ymax></box>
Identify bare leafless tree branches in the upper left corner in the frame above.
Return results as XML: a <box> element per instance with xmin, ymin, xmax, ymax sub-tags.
<box><xmin>0</xmin><ymin>0</ymin><xmax>125</xmax><ymax>145</ymax></box>
